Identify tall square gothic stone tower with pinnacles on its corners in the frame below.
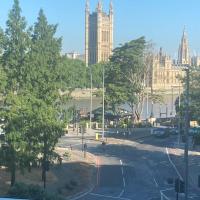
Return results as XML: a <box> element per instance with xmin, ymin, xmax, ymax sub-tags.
<box><xmin>85</xmin><ymin>1</ymin><xmax>113</xmax><ymax>65</ymax></box>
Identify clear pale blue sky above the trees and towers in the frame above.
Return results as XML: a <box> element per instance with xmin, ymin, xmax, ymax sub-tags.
<box><xmin>0</xmin><ymin>0</ymin><xmax>200</xmax><ymax>57</ymax></box>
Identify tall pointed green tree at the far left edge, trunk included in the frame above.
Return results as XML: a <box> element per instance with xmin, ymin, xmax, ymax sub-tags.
<box><xmin>0</xmin><ymin>0</ymin><xmax>29</xmax><ymax>186</ymax></box>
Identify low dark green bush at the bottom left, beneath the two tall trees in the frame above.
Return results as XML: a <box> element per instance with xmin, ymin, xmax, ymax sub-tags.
<box><xmin>8</xmin><ymin>183</ymin><xmax>64</xmax><ymax>200</ymax></box>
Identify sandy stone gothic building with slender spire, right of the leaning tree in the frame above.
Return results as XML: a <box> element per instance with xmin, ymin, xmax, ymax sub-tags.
<box><xmin>146</xmin><ymin>29</ymin><xmax>190</xmax><ymax>91</ymax></box>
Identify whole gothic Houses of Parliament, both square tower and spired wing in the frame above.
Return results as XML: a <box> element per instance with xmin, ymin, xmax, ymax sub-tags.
<box><xmin>85</xmin><ymin>1</ymin><xmax>197</xmax><ymax>91</ymax></box>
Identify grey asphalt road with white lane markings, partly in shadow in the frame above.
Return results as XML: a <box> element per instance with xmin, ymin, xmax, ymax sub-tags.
<box><xmin>57</xmin><ymin>132</ymin><xmax>200</xmax><ymax>200</ymax></box>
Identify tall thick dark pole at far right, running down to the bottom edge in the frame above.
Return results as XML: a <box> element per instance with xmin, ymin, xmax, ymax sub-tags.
<box><xmin>184</xmin><ymin>66</ymin><xmax>190</xmax><ymax>200</ymax></box>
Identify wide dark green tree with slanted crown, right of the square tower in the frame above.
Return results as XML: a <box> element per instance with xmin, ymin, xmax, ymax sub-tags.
<box><xmin>106</xmin><ymin>37</ymin><xmax>146</xmax><ymax>120</ymax></box>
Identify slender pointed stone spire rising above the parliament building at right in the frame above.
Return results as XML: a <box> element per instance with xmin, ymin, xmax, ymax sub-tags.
<box><xmin>178</xmin><ymin>28</ymin><xmax>190</xmax><ymax>65</ymax></box>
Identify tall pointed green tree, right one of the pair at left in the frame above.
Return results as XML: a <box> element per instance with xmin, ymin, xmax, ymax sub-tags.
<box><xmin>27</xmin><ymin>10</ymin><xmax>64</xmax><ymax>187</ymax></box>
